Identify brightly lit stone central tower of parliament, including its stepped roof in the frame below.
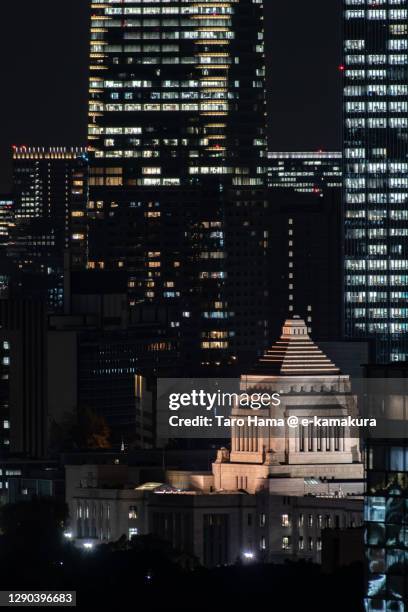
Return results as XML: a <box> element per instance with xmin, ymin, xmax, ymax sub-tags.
<box><xmin>213</xmin><ymin>317</ymin><xmax>363</xmax><ymax>495</ymax></box>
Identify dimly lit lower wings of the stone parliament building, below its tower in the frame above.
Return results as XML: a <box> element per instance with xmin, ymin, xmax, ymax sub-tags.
<box><xmin>66</xmin><ymin>463</ymin><xmax>363</xmax><ymax>567</ymax></box>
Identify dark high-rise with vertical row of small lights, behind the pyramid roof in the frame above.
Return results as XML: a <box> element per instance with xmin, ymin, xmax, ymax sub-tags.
<box><xmin>267</xmin><ymin>187</ymin><xmax>342</xmax><ymax>341</ymax></box>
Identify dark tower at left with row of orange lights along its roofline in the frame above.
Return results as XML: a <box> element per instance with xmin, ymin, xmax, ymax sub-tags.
<box><xmin>10</xmin><ymin>146</ymin><xmax>88</xmax><ymax>311</ymax></box>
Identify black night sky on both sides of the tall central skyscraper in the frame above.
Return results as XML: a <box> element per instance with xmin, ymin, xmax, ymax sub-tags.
<box><xmin>0</xmin><ymin>0</ymin><xmax>342</xmax><ymax>192</ymax></box>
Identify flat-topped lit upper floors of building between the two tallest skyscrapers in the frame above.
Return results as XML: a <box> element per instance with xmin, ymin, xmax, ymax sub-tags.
<box><xmin>268</xmin><ymin>151</ymin><xmax>343</xmax><ymax>193</ymax></box>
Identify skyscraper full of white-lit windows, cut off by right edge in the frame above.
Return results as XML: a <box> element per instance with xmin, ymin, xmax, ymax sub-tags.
<box><xmin>340</xmin><ymin>0</ymin><xmax>408</xmax><ymax>363</ymax></box>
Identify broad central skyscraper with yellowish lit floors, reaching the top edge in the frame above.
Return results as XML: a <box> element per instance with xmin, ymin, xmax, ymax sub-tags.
<box><xmin>88</xmin><ymin>0</ymin><xmax>268</xmax><ymax>365</ymax></box>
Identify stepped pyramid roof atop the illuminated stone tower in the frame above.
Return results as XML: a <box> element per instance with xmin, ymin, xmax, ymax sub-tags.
<box><xmin>252</xmin><ymin>317</ymin><xmax>340</xmax><ymax>376</ymax></box>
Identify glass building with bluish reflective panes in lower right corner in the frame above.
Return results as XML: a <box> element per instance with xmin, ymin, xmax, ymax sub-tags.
<box><xmin>365</xmin><ymin>363</ymin><xmax>408</xmax><ymax>612</ymax></box>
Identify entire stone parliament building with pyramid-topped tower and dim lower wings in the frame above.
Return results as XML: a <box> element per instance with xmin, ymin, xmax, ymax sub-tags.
<box><xmin>62</xmin><ymin>319</ymin><xmax>364</xmax><ymax>567</ymax></box>
